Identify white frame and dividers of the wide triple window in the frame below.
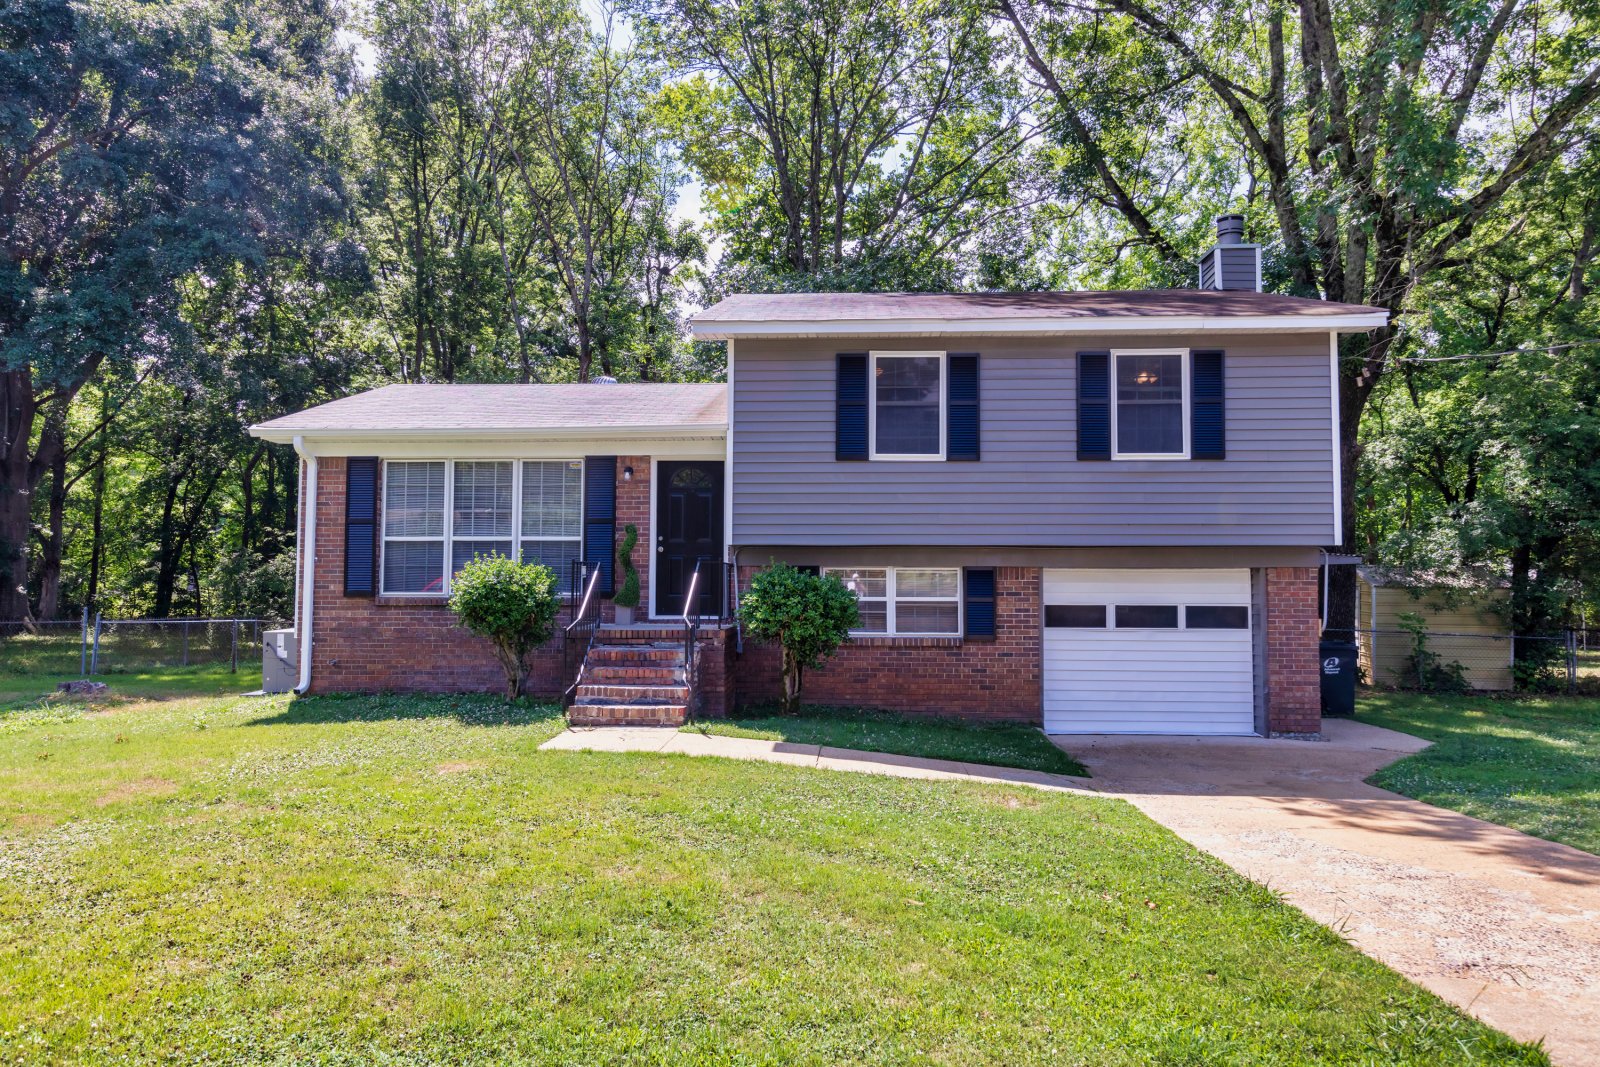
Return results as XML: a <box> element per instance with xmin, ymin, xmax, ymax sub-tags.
<box><xmin>378</xmin><ymin>456</ymin><xmax>584</xmax><ymax>597</ymax></box>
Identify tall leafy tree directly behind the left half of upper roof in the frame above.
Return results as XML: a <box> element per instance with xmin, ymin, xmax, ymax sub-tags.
<box><xmin>626</xmin><ymin>0</ymin><xmax>1030</xmax><ymax>290</ymax></box>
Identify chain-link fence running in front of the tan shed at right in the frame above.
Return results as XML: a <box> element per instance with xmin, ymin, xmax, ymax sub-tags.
<box><xmin>1326</xmin><ymin>630</ymin><xmax>1600</xmax><ymax>693</ymax></box>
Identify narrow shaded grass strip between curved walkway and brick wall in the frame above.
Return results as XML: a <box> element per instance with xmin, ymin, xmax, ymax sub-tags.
<box><xmin>683</xmin><ymin>707</ymin><xmax>1090</xmax><ymax>777</ymax></box>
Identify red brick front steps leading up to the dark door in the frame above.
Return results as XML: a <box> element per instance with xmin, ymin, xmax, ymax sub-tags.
<box><xmin>566</xmin><ymin>625</ymin><xmax>690</xmax><ymax>726</ymax></box>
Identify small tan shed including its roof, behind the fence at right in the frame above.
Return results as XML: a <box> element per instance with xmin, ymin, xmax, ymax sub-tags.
<box><xmin>1355</xmin><ymin>566</ymin><xmax>1512</xmax><ymax>689</ymax></box>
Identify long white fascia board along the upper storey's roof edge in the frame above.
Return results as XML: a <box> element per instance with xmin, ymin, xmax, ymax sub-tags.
<box><xmin>690</xmin><ymin>312</ymin><xmax>1389</xmax><ymax>341</ymax></box>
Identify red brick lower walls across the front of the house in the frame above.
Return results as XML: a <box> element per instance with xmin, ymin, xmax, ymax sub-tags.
<box><xmin>300</xmin><ymin>456</ymin><xmax>1322</xmax><ymax>733</ymax></box>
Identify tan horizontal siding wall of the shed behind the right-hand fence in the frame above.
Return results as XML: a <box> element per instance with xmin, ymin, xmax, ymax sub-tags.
<box><xmin>1355</xmin><ymin>579</ymin><xmax>1512</xmax><ymax>689</ymax></box>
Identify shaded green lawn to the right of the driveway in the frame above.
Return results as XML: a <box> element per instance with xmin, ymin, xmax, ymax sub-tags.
<box><xmin>1357</xmin><ymin>693</ymin><xmax>1600</xmax><ymax>854</ymax></box>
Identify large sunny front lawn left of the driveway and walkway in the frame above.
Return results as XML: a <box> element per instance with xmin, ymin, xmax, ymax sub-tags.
<box><xmin>0</xmin><ymin>696</ymin><xmax>1547</xmax><ymax>1067</ymax></box>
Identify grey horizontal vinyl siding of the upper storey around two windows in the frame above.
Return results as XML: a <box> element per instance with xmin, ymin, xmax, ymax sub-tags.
<box><xmin>733</xmin><ymin>334</ymin><xmax>1333</xmax><ymax>545</ymax></box>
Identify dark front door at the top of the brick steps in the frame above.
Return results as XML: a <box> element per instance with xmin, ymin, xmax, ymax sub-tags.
<box><xmin>656</xmin><ymin>462</ymin><xmax>723</xmax><ymax>616</ymax></box>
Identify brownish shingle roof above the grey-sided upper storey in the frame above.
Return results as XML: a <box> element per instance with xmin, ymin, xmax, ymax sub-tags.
<box><xmin>693</xmin><ymin>290</ymin><xmax>1386</xmax><ymax>338</ymax></box>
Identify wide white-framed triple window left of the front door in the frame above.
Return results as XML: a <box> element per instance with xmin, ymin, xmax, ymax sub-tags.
<box><xmin>382</xmin><ymin>459</ymin><xmax>584</xmax><ymax>597</ymax></box>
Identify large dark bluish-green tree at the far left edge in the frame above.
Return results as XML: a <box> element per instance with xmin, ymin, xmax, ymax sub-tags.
<box><xmin>0</xmin><ymin>0</ymin><xmax>348</xmax><ymax>617</ymax></box>
